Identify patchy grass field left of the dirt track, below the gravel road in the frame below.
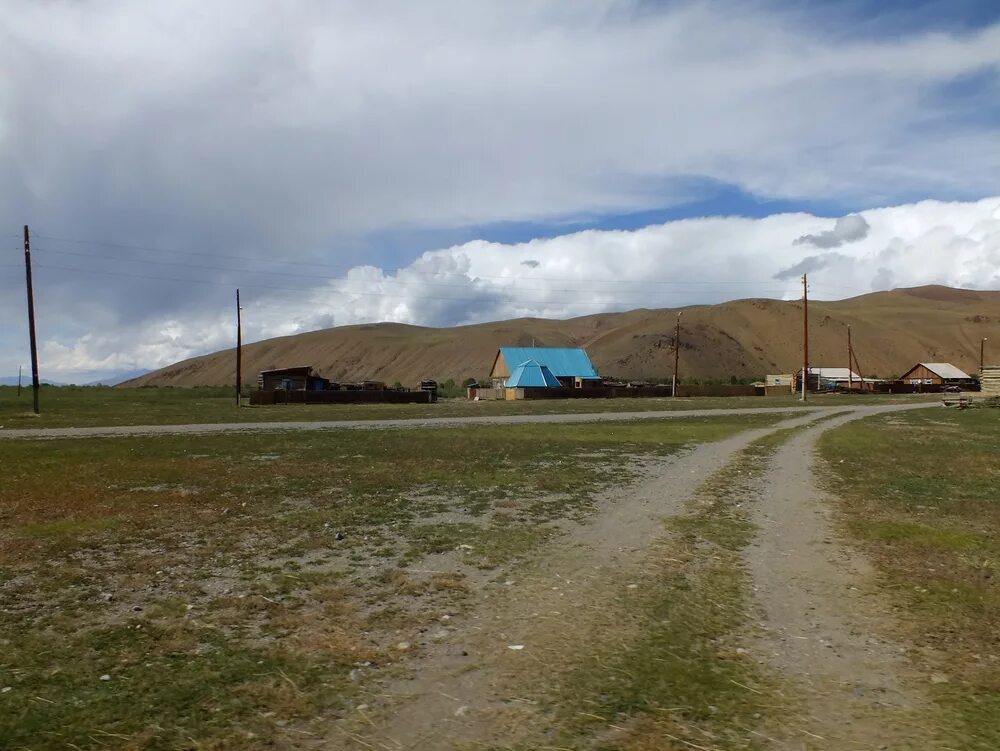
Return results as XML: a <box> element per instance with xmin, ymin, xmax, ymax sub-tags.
<box><xmin>0</xmin><ymin>415</ymin><xmax>776</xmax><ymax>749</ymax></box>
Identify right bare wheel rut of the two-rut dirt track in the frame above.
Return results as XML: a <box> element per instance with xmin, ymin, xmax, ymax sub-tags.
<box><xmin>746</xmin><ymin>409</ymin><xmax>939</xmax><ymax>751</ymax></box>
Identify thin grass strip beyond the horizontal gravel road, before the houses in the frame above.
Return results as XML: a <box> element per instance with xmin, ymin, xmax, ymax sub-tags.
<box><xmin>0</xmin><ymin>386</ymin><xmax>933</xmax><ymax>430</ymax></box>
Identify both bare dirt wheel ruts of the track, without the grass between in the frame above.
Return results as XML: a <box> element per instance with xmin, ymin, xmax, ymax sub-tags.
<box><xmin>338</xmin><ymin>405</ymin><xmax>928</xmax><ymax>750</ymax></box>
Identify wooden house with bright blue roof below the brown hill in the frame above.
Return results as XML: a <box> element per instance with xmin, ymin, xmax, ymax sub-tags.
<box><xmin>490</xmin><ymin>347</ymin><xmax>601</xmax><ymax>389</ymax></box>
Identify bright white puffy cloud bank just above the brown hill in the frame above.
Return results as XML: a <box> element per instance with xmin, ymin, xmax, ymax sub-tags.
<box><xmin>29</xmin><ymin>197</ymin><xmax>1000</xmax><ymax>372</ymax></box>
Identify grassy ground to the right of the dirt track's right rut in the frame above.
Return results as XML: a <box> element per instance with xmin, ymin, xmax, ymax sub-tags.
<box><xmin>821</xmin><ymin>409</ymin><xmax>1000</xmax><ymax>751</ymax></box>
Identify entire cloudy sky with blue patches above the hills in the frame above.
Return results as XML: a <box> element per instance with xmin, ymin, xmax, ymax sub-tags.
<box><xmin>0</xmin><ymin>0</ymin><xmax>1000</xmax><ymax>381</ymax></box>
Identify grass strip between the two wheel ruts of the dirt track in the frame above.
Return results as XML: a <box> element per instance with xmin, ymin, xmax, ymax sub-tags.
<box><xmin>512</xmin><ymin>430</ymin><xmax>794</xmax><ymax>751</ymax></box>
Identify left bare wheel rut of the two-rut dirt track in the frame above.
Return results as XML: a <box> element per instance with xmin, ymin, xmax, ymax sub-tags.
<box><xmin>339</xmin><ymin>409</ymin><xmax>839</xmax><ymax>751</ymax></box>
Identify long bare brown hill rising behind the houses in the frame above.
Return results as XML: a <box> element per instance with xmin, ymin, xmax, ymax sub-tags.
<box><xmin>122</xmin><ymin>286</ymin><xmax>1000</xmax><ymax>387</ymax></box>
